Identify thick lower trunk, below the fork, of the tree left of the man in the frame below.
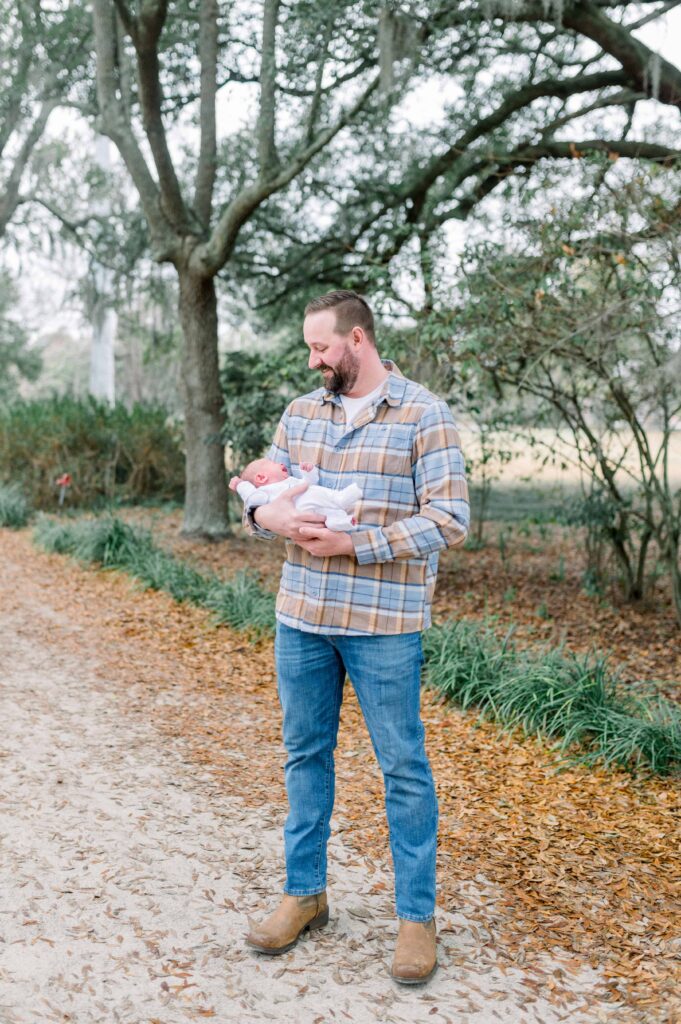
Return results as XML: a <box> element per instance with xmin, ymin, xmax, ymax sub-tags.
<box><xmin>178</xmin><ymin>267</ymin><xmax>231</xmax><ymax>541</ymax></box>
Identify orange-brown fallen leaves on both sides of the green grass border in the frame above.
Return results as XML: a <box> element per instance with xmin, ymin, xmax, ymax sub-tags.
<box><xmin>5</xmin><ymin>520</ymin><xmax>681</xmax><ymax>1021</ymax></box>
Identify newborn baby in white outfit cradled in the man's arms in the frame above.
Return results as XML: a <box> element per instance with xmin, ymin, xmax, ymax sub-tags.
<box><xmin>229</xmin><ymin>459</ymin><xmax>361</xmax><ymax>532</ymax></box>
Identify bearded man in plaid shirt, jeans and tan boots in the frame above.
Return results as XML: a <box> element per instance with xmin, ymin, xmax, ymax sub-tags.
<box><xmin>244</xmin><ymin>291</ymin><xmax>469</xmax><ymax>984</ymax></box>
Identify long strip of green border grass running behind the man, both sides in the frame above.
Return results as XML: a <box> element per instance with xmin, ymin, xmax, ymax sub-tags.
<box><xmin>34</xmin><ymin>516</ymin><xmax>681</xmax><ymax>775</ymax></box>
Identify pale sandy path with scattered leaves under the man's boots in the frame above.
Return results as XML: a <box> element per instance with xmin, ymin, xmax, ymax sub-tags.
<box><xmin>0</xmin><ymin>552</ymin><xmax>625</xmax><ymax>1024</ymax></box>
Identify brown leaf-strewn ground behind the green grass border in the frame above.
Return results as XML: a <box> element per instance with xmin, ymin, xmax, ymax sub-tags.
<box><xmin>124</xmin><ymin>509</ymin><xmax>681</xmax><ymax>700</ymax></box>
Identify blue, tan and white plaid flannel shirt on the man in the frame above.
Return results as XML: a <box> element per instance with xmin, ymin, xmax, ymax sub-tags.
<box><xmin>244</xmin><ymin>359</ymin><xmax>469</xmax><ymax>636</ymax></box>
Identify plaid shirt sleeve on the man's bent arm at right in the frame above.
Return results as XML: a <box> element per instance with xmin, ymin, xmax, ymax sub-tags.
<box><xmin>349</xmin><ymin>401</ymin><xmax>470</xmax><ymax>564</ymax></box>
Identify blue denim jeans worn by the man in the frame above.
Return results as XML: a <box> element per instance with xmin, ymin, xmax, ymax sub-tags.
<box><xmin>274</xmin><ymin>622</ymin><xmax>437</xmax><ymax>921</ymax></box>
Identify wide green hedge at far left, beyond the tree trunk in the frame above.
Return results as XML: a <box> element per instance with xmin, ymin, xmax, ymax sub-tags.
<box><xmin>0</xmin><ymin>397</ymin><xmax>184</xmax><ymax>509</ymax></box>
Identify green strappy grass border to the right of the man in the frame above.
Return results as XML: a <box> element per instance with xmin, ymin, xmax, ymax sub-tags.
<box><xmin>424</xmin><ymin>622</ymin><xmax>681</xmax><ymax>774</ymax></box>
